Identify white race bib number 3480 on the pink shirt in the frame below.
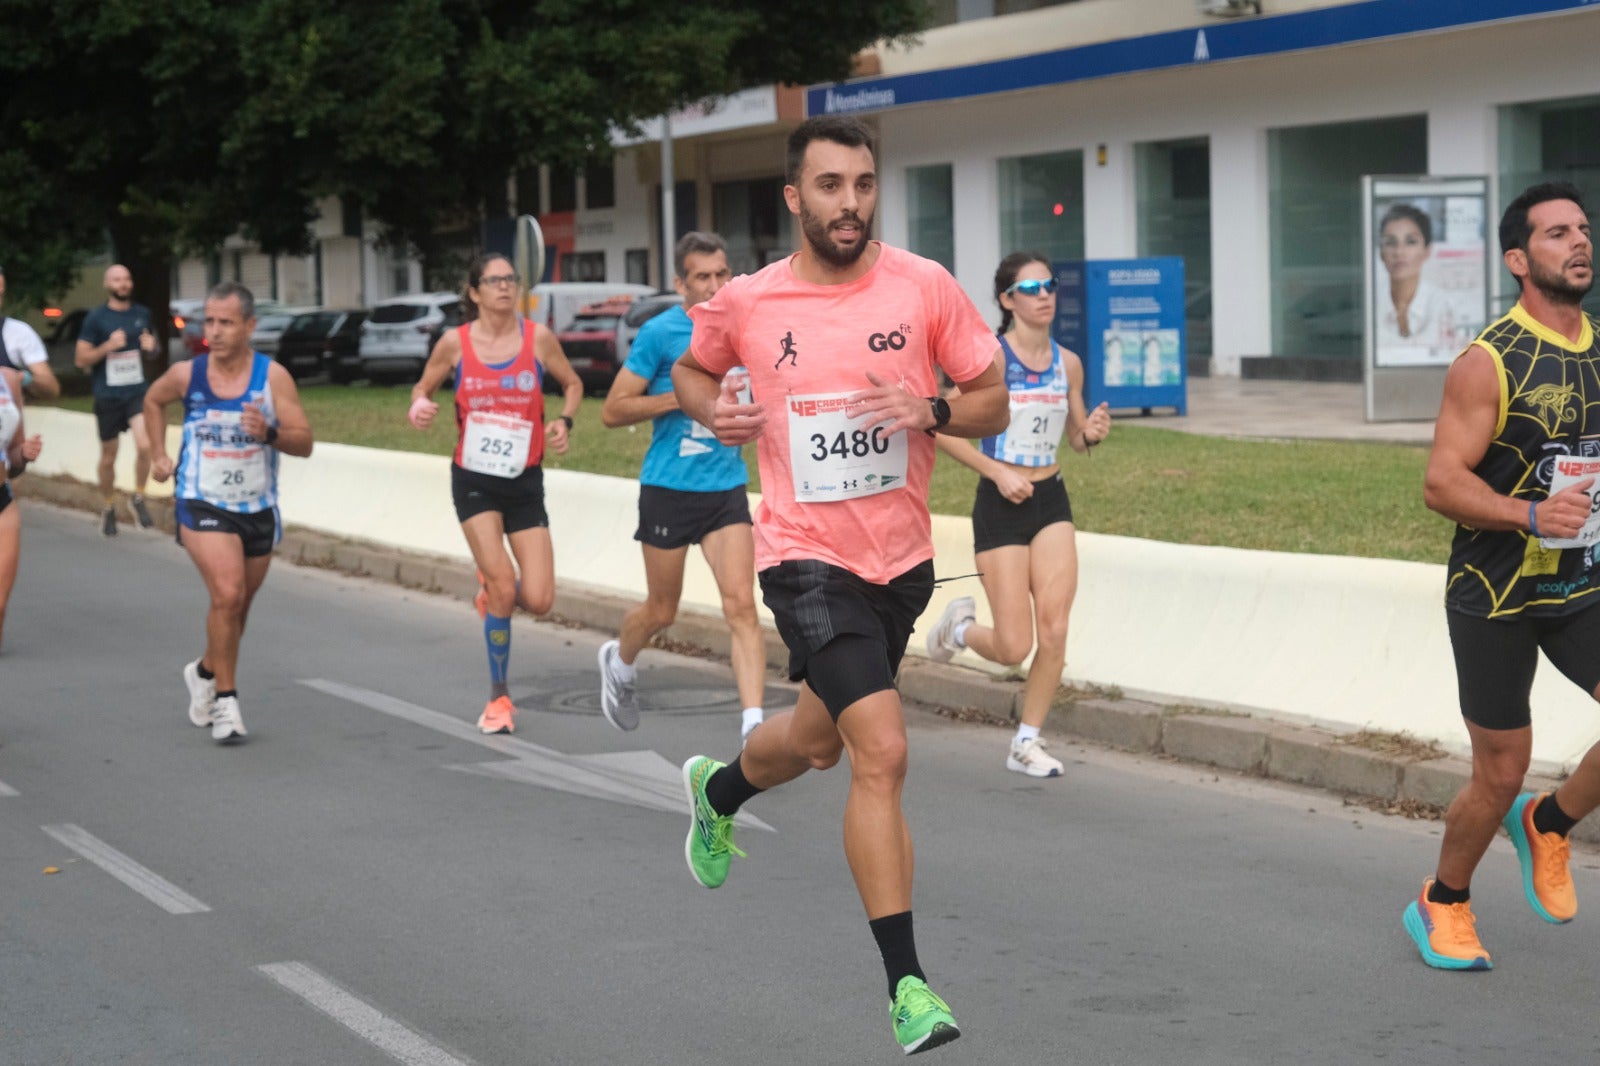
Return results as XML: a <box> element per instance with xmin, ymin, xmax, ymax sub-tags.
<box><xmin>789</xmin><ymin>392</ymin><xmax>906</xmax><ymax>503</ymax></box>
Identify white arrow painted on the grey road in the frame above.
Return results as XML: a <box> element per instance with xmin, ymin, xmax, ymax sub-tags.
<box><xmin>299</xmin><ymin>677</ymin><xmax>776</xmax><ymax>832</ymax></box>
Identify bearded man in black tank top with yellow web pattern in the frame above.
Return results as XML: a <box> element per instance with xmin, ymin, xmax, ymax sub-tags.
<box><xmin>1403</xmin><ymin>182</ymin><xmax>1600</xmax><ymax>970</ymax></box>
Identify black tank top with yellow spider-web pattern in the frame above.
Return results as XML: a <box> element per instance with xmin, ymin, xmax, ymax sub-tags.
<box><xmin>1445</xmin><ymin>304</ymin><xmax>1600</xmax><ymax>618</ymax></box>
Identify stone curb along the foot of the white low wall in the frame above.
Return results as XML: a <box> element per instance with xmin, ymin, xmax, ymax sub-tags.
<box><xmin>13</xmin><ymin>475</ymin><xmax>1580</xmax><ymax>844</ymax></box>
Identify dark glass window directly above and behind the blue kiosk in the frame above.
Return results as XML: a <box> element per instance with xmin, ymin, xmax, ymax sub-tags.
<box><xmin>1134</xmin><ymin>138</ymin><xmax>1211</xmax><ymax>355</ymax></box>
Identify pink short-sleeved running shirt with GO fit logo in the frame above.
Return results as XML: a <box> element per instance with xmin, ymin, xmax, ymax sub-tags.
<box><xmin>690</xmin><ymin>243</ymin><xmax>1000</xmax><ymax>584</ymax></box>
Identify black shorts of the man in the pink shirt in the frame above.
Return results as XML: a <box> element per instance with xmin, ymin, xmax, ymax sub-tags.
<box><xmin>760</xmin><ymin>559</ymin><xmax>933</xmax><ymax>720</ymax></box>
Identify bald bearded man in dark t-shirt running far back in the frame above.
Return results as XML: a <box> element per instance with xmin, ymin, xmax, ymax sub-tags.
<box><xmin>74</xmin><ymin>264</ymin><xmax>155</xmax><ymax>536</ymax></box>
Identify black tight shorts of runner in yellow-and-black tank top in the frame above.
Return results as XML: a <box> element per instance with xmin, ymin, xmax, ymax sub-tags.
<box><xmin>1445</xmin><ymin>607</ymin><xmax>1600</xmax><ymax>730</ymax></box>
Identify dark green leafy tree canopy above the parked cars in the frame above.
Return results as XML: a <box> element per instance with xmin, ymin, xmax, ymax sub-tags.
<box><xmin>0</xmin><ymin>0</ymin><xmax>928</xmax><ymax>348</ymax></box>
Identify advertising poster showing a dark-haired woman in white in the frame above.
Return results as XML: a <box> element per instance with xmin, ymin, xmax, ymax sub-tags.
<box><xmin>1368</xmin><ymin>178</ymin><xmax>1488</xmax><ymax>368</ymax></box>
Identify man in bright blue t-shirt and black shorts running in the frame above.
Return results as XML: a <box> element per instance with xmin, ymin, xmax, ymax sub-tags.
<box><xmin>600</xmin><ymin>232</ymin><xmax>766</xmax><ymax>736</ymax></box>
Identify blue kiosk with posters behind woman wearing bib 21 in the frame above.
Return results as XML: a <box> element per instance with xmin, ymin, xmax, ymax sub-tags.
<box><xmin>1051</xmin><ymin>256</ymin><xmax>1189</xmax><ymax>415</ymax></box>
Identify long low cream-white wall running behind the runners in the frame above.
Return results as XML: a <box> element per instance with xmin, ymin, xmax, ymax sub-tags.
<box><xmin>27</xmin><ymin>408</ymin><xmax>1600</xmax><ymax>768</ymax></box>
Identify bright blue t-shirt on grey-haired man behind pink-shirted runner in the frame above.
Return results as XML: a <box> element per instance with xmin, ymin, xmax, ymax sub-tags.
<box><xmin>622</xmin><ymin>307</ymin><xmax>750</xmax><ymax>493</ymax></box>
